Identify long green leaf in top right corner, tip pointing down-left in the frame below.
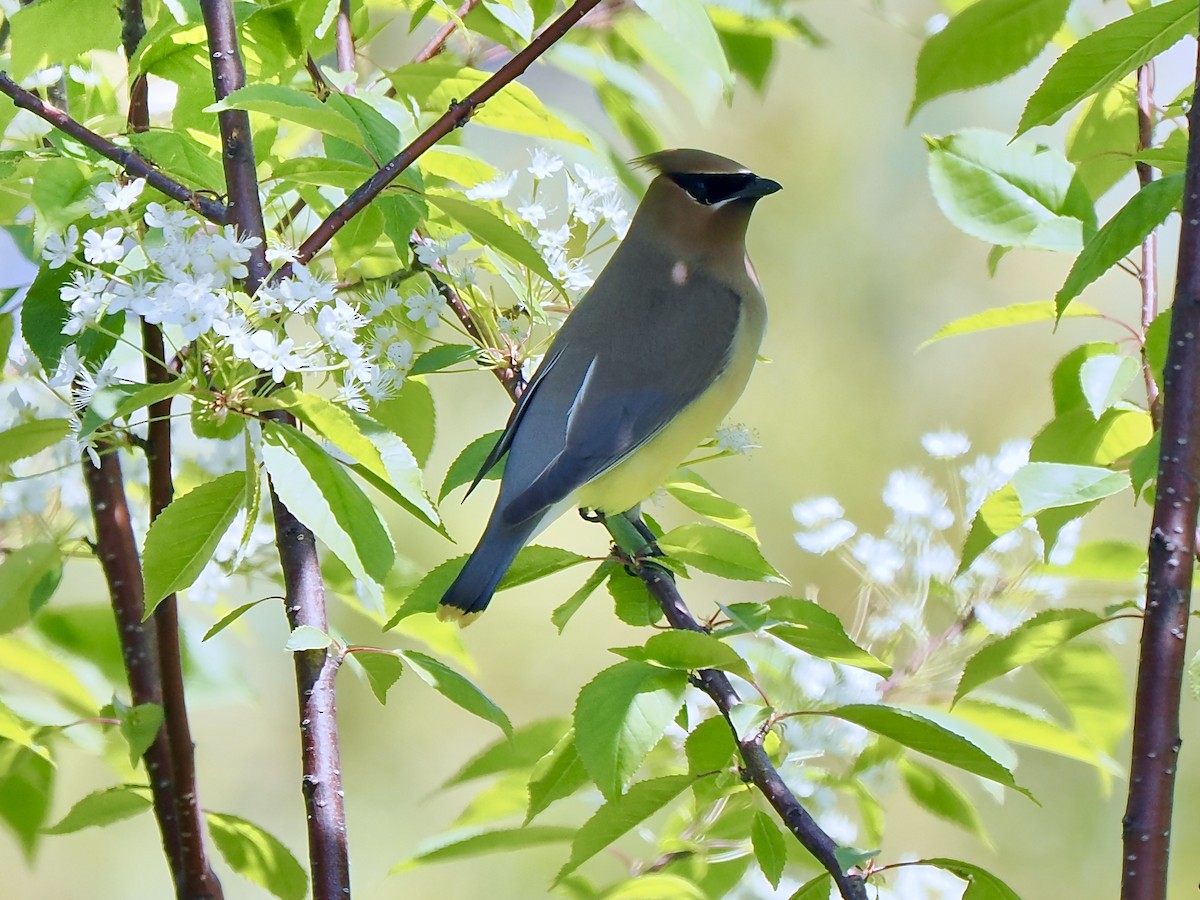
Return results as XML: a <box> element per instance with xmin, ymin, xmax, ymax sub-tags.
<box><xmin>1016</xmin><ymin>0</ymin><xmax>1196</xmax><ymax>134</ymax></box>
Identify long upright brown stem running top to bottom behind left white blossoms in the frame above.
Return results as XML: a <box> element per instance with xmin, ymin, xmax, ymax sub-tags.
<box><xmin>202</xmin><ymin>0</ymin><xmax>350</xmax><ymax>900</ymax></box>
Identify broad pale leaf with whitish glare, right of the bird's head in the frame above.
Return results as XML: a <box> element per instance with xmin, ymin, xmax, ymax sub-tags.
<box><xmin>925</xmin><ymin>128</ymin><xmax>1096</xmax><ymax>253</ymax></box>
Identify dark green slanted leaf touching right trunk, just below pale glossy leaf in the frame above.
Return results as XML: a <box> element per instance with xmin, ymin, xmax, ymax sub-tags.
<box><xmin>1054</xmin><ymin>175</ymin><xmax>1183</xmax><ymax>314</ymax></box>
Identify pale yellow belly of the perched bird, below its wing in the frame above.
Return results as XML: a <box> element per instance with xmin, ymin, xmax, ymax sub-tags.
<box><xmin>576</xmin><ymin>298</ymin><xmax>764</xmax><ymax>515</ymax></box>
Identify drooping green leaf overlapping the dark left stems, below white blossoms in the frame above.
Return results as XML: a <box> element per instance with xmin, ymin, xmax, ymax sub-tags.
<box><xmin>142</xmin><ymin>472</ymin><xmax>246</xmax><ymax>620</ymax></box>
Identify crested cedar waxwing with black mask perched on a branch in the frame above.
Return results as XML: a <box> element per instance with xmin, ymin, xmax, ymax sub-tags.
<box><xmin>438</xmin><ymin>150</ymin><xmax>780</xmax><ymax>624</ymax></box>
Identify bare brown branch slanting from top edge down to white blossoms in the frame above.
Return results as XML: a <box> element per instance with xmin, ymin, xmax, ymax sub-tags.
<box><xmin>289</xmin><ymin>0</ymin><xmax>600</xmax><ymax>270</ymax></box>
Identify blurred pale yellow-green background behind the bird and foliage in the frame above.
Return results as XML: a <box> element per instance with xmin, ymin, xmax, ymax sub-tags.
<box><xmin>0</xmin><ymin>0</ymin><xmax>1200</xmax><ymax>900</ymax></box>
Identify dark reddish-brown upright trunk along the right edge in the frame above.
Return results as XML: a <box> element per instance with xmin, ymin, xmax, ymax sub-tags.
<box><xmin>1121</xmin><ymin>31</ymin><xmax>1200</xmax><ymax>900</ymax></box>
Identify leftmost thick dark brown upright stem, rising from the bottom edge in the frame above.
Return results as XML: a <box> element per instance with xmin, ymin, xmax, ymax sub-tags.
<box><xmin>83</xmin><ymin>445</ymin><xmax>188</xmax><ymax>900</ymax></box>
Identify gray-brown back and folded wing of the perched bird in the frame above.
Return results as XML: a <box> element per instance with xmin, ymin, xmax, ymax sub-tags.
<box><xmin>497</xmin><ymin>260</ymin><xmax>740</xmax><ymax>524</ymax></box>
